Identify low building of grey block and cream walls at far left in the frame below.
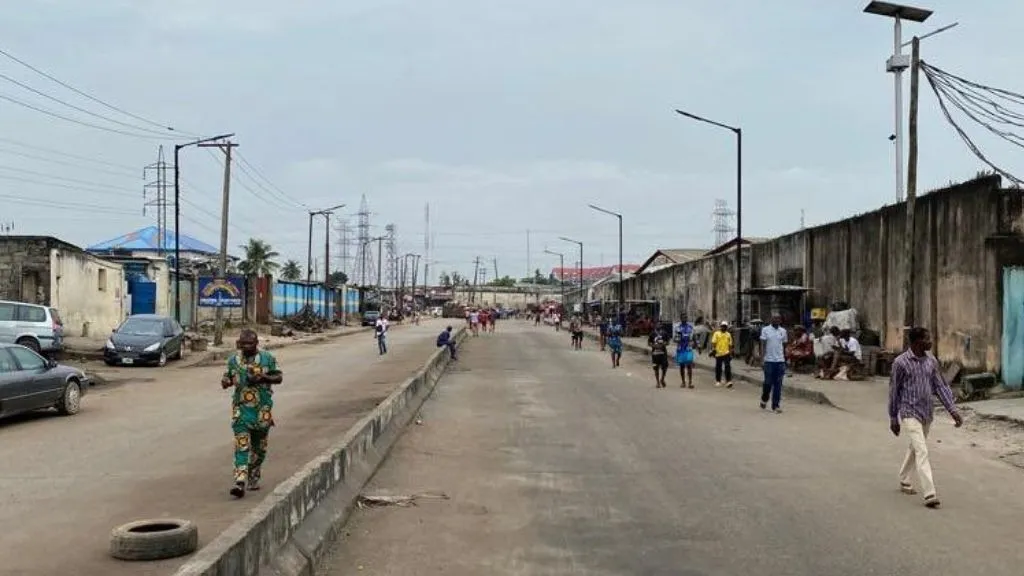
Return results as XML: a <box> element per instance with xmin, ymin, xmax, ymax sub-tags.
<box><xmin>0</xmin><ymin>236</ymin><xmax>127</xmax><ymax>336</ymax></box>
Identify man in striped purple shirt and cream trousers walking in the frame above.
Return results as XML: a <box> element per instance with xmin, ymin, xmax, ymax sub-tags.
<box><xmin>889</xmin><ymin>327</ymin><xmax>964</xmax><ymax>508</ymax></box>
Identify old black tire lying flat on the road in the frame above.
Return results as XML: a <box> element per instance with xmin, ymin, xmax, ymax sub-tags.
<box><xmin>111</xmin><ymin>518</ymin><xmax>199</xmax><ymax>561</ymax></box>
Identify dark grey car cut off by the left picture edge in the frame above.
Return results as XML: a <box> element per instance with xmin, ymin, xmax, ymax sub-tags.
<box><xmin>0</xmin><ymin>344</ymin><xmax>89</xmax><ymax>418</ymax></box>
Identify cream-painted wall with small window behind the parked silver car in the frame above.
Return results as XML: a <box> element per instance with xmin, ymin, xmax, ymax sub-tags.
<box><xmin>49</xmin><ymin>246</ymin><xmax>128</xmax><ymax>336</ymax></box>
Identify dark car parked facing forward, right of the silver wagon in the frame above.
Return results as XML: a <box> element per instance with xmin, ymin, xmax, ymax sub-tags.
<box><xmin>103</xmin><ymin>314</ymin><xmax>185</xmax><ymax>366</ymax></box>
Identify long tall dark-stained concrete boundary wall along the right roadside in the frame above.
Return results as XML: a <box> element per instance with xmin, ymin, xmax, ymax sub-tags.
<box><xmin>598</xmin><ymin>176</ymin><xmax>1024</xmax><ymax>371</ymax></box>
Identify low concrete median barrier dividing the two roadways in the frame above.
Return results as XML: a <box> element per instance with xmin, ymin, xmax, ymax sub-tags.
<box><xmin>174</xmin><ymin>327</ymin><xmax>466</xmax><ymax>576</ymax></box>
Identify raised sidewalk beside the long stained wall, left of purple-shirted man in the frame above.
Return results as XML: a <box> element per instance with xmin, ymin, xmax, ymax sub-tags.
<box><xmin>586</xmin><ymin>328</ymin><xmax>888</xmax><ymax>417</ymax></box>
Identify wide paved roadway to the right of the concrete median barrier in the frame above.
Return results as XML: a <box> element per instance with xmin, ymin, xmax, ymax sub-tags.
<box><xmin>322</xmin><ymin>323</ymin><xmax>1024</xmax><ymax>576</ymax></box>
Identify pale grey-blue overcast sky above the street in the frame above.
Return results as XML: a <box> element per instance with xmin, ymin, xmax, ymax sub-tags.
<box><xmin>0</xmin><ymin>0</ymin><xmax>1024</xmax><ymax>278</ymax></box>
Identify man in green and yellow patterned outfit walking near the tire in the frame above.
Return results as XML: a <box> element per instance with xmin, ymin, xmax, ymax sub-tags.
<box><xmin>220</xmin><ymin>330</ymin><xmax>283</xmax><ymax>498</ymax></box>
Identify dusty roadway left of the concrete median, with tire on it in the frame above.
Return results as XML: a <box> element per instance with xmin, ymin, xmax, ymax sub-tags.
<box><xmin>0</xmin><ymin>322</ymin><xmax>441</xmax><ymax>576</ymax></box>
